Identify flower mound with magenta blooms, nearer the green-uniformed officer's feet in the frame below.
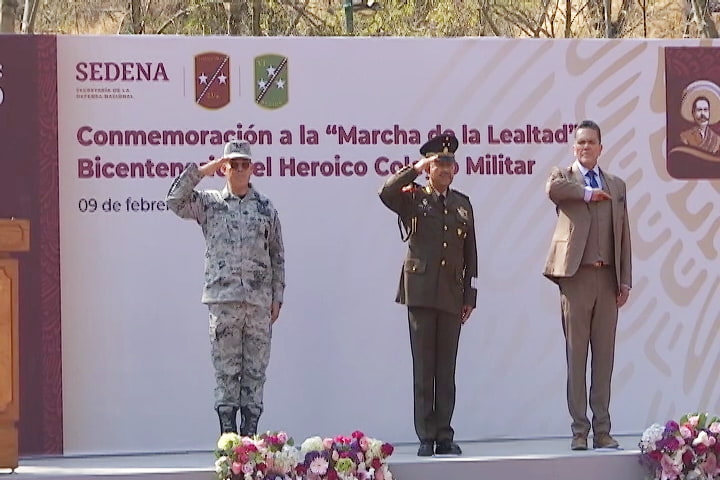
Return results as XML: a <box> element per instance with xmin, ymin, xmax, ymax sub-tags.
<box><xmin>296</xmin><ymin>431</ymin><xmax>393</xmax><ymax>480</ymax></box>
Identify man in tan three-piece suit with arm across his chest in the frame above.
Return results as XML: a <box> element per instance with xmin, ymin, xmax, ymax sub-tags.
<box><xmin>543</xmin><ymin>120</ymin><xmax>632</xmax><ymax>450</ymax></box>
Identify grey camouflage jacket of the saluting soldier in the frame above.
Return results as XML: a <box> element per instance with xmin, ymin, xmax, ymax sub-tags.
<box><xmin>167</xmin><ymin>164</ymin><xmax>285</xmax><ymax>308</ymax></box>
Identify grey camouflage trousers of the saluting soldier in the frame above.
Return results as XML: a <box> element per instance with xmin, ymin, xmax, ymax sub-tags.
<box><xmin>208</xmin><ymin>303</ymin><xmax>272</xmax><ymax>417</ymax></box>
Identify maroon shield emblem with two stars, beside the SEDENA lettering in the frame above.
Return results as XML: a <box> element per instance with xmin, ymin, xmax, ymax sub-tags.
<box><xmin>195</xmin><ymin>52</ymin><xmax>230</xmax><ymax>109</ymax></box>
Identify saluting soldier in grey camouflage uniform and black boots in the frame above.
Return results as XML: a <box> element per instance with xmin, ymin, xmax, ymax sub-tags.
<box><xmin>167</xmin><ymin>141</ymin><xmax>285</xmax><ymax>435</ymax></box>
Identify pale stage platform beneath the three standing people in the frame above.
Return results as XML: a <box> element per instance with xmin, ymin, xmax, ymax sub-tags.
<box><xmin>0</xmin><ymin>436</ymin><xmax>643</xmax><ymax>480</ymax></box>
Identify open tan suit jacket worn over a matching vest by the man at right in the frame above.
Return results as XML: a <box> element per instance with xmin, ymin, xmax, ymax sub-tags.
<box><xmin>543</xmin><ymin>163</ymin><xmax>632</xmax><ymax>287</ymax></box>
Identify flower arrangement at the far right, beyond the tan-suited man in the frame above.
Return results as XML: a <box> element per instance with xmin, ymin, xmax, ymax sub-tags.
<box><xmin>639</xmin><ymin>413</ymin><xmax>720</xmax><ymax>480</ymax></box>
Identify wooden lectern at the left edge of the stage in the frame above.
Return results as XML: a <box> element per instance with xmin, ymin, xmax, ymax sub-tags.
<box><xmin>0</xmin><ymin>219</ymin><xmax>30</xmax><ymax>471</ymax></box>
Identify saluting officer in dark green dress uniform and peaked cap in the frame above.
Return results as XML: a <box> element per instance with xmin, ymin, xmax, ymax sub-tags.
<box><xmin>380</xmin><ymin>134</ymin><xmax>477</xmax><ymax>456</ymax></box>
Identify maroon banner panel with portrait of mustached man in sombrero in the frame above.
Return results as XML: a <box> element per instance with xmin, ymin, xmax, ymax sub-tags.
<box><xmin>665</xmin><ymin>47</ymin><xmax>720</xmax><ymax>179</ymax></box>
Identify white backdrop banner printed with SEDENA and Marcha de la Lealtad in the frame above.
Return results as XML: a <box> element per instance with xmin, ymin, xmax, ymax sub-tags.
<box><xmin>58</xmin><ymin>36</ymin><xmax>720</xmax><ymax>454</ymax></box>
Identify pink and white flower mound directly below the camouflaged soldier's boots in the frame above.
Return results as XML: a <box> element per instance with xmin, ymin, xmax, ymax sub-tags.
<box><xmin>215</xmin><ymin>432</ymin><xmax>300</xmax><ymax>480</ymax></box>
